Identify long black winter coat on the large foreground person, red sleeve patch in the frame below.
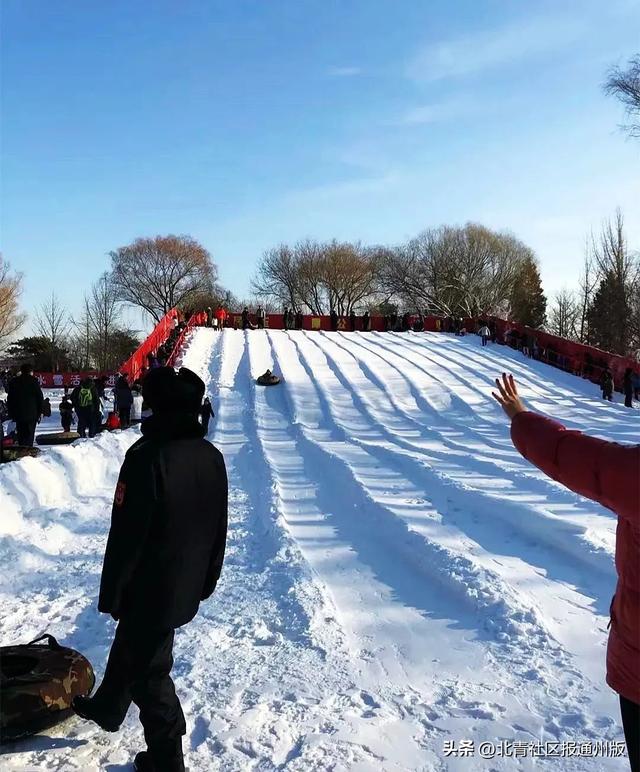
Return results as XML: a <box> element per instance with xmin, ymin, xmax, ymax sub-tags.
<box><xmin>98</xmin><ymin>414</ymin><xmax>227</xmax><ymax>628</ymax></box>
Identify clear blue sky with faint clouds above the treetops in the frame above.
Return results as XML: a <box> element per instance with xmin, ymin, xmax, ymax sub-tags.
<box><xmin>0</xmin><ymin>0</ymin><xmax>640</xmax><ymax>334</ymax></box>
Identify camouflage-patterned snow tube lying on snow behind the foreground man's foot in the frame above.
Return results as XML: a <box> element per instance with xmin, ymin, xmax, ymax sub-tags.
<box><xmin>0</xmin><ymin>635</ymin><xmax>95</xmax><ymax>743</ymax></box>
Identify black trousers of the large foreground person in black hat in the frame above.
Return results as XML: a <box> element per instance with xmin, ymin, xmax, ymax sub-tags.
<box><xmin>94</xmin><ymin>619</ymin><xmax>186</xmax><ymax>772</ymax></box>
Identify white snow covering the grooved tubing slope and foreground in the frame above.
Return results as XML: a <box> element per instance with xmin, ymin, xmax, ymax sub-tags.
<box><xmin>0</xmin><ymin>329</ymin><xmax>640</xmax><ymax>772</ymax></box>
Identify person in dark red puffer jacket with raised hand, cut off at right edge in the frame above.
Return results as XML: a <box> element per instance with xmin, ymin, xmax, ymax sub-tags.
<box><xmin>493</xmin><ymin>373</ymin><xmax>640</xmax><ymax>772</ymax></box>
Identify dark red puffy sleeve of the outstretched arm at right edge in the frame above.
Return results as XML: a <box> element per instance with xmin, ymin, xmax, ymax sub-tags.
<box><xmin>511</xmin><ymin>411</ymin><xmax>640</xmax><ymax>523</ymax></box>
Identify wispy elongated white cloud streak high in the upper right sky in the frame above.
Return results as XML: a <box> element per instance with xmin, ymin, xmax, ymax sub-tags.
<box><xmin>406</xmin><ymin>17</ymin><xmax>586</xmax><ymax>82</ymax></box>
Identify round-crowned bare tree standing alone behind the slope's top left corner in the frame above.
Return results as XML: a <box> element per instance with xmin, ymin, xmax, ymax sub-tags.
<box><xmin>110</xmin><ymin>236</ymin><xmax>217</xmax><ymax>321</ymax></box>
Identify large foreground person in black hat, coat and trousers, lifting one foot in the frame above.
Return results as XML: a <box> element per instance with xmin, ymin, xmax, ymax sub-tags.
<box><xmin>73</xmin><ymin>367</ymin><xmax>227</xmax><ymax>772</ymax></box>
